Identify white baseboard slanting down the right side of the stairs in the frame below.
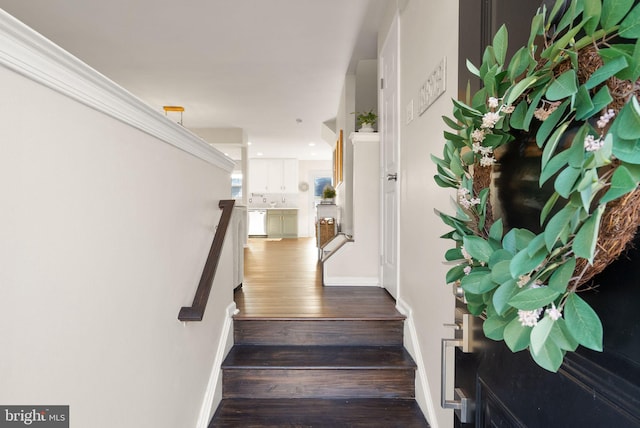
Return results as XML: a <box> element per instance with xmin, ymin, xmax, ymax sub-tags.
<box><xmin>396</xmin><ymin>299</ymin><xmax>438</xmax><ymax>428</ymax></box>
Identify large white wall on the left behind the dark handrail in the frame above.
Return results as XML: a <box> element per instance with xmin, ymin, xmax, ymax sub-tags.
<box><xmin>0</xmin><ymin>61</ymin><xmax>233</xmax><ymax>428</ymax></box>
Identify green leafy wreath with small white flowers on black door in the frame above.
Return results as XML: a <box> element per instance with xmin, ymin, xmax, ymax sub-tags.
<box><xmin>432</xmin><ymin>0</ymin><xmax>640</xmax><ymax>372</ymax></box>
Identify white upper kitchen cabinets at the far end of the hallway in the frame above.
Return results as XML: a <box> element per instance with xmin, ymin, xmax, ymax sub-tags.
<box><xmin>249</xmin><ymin>159</ymin><xmax>298</xmax><ymax>193</ymax></box>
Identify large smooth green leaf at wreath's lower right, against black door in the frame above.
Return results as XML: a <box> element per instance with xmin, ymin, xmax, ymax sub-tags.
<box><xmin>564</xmin><ymin>293</ymin><xmax>602</xmax><ymax>352</ymax></box>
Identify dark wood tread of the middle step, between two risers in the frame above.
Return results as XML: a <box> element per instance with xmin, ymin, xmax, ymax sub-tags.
<box><xmin>222</xmin><ymin>345</ymin><xmax>416</xmax><ymax>370</ymax></box>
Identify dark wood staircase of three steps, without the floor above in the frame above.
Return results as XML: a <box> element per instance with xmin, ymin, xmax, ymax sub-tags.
<box><xmin>209</xmin><ymin>311</ymin><xmax>429</xmax><ymax>428</ymax></box>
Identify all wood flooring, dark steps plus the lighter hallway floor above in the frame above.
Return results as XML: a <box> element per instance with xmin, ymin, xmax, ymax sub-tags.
<box><xmin>209</xmin><ymin>239</ymin><xmax>429</xmax><ymax>428</ymax></box>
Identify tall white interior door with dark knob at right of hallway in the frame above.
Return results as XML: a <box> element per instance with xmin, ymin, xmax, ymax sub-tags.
<box><xmin>379</xmin><ymin>17</ymin><xmax>399</xmax><ymax>298</ymax></box>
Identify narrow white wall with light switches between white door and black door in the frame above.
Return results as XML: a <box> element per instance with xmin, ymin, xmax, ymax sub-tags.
<box><xmin>390</xmin><ymin>0</ymin><xmax>458</xmax><ymax>427</ymax></box>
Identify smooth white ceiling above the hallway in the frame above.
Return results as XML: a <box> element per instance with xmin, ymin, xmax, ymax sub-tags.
<box><xmin>0</xmin><ymin>0</ymin><xmax>385</xmax><ymax>159</ymax></box>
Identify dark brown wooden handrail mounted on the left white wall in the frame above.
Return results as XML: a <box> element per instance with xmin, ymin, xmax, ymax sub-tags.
<box><xmin>178</xmin><ymin>199</ymin><xmax>235</xmax><ymax>321</ymax></box>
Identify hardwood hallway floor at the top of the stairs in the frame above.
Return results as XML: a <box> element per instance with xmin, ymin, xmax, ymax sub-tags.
<box><xmin>235</xmin><ymin>238</ymin><xmax>402</xmax><ymax>320</ymax></box>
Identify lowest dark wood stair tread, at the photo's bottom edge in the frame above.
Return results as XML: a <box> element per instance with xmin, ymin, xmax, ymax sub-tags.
<box><xmin>209</xmin><ymin>398</ymin><xmax>429</xmax><ymax>428</ymax></box>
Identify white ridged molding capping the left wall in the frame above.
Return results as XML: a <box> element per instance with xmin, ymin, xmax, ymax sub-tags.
<box><xmin>0</xmin><ymin>9</ymin><xmax>235</xmax><ymax>172</ymax></box>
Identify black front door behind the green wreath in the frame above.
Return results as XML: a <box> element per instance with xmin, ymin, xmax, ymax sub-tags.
<box><xmin>450</xmin><ymin>0</ymin><xmax>640</xmax><ymax>428</ymax></box>
